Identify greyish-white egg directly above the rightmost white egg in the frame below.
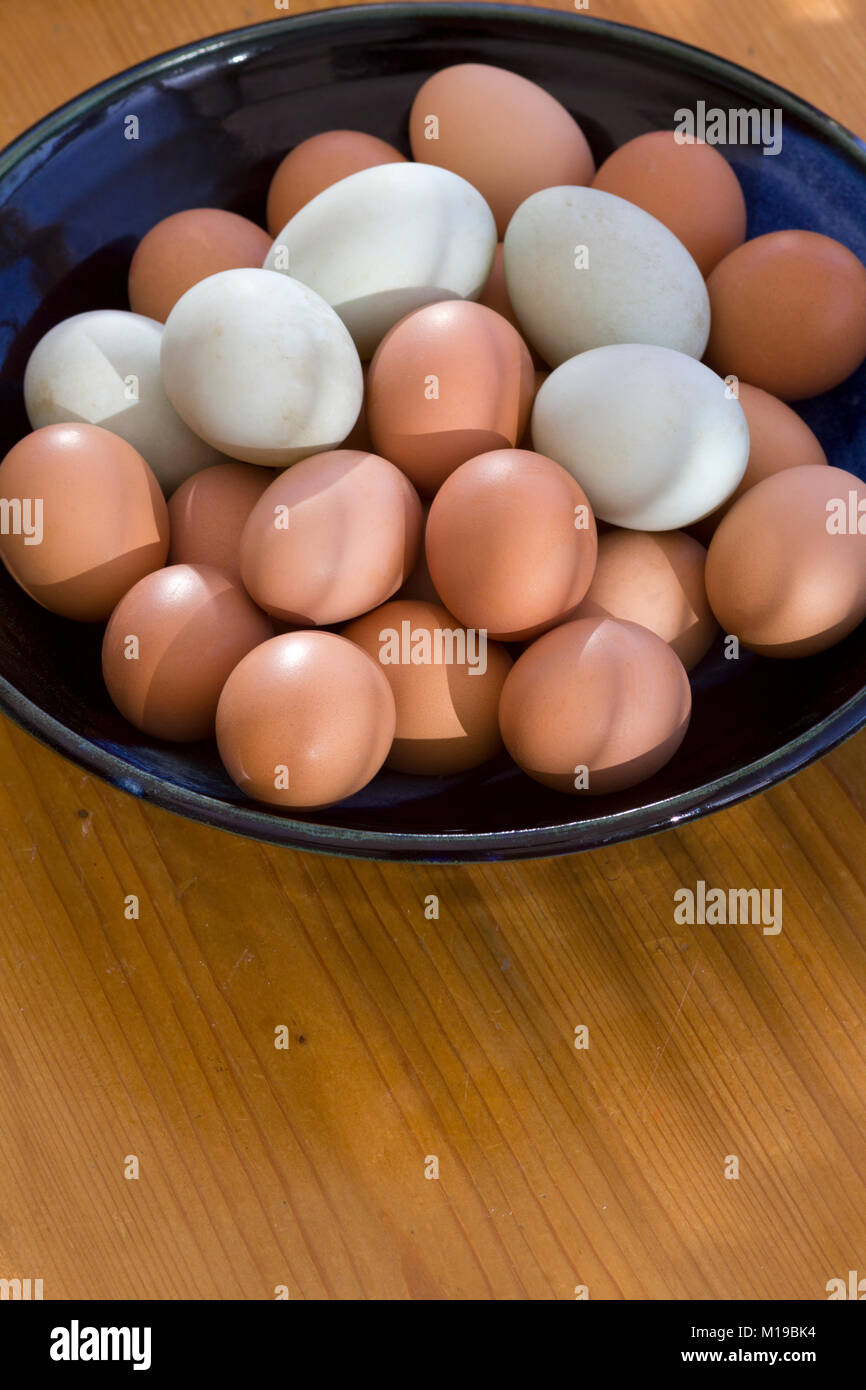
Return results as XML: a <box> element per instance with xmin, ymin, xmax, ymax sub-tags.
<box><xmin>503</xmin><ymin>188</ymin><xmax>710</xmax><ymax>367</ymax></box>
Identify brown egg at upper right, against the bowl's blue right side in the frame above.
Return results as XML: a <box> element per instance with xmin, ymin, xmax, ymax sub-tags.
<box><xmin>706</xmin><ymin>231</ymin><xmax>866</xmax><ymax>400</ymax></box>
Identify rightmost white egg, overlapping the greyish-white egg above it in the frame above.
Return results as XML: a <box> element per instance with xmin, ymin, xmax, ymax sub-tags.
<box><xmin>532</xmin><ymin>343</ymin><xmax>749</xmax><ymax>531</ymax></box>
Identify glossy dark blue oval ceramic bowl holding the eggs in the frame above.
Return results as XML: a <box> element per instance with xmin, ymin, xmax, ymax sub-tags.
<box><xmin>0</xmin><ymin>4</ymin><xmax>866</xmax><ymax>860</ymax></box>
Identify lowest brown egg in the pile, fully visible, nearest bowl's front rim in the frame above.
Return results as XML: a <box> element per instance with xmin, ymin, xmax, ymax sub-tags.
<box><xmin>217</xmin><ymin>632</ymin><xmax>396</xmax><ymax>808</ymax></box>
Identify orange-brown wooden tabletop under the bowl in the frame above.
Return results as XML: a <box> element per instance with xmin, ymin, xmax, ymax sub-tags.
<box><xmin>0</xmin><ymin>0</ymin><xmax>866</xmax><ymax>1300</ymax></box>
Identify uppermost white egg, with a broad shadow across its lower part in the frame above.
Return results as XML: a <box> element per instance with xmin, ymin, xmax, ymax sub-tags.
<box><xmin>264</xmin><ymin>164</ymin><xmax>496</xmax><ymax>357</ymax></box>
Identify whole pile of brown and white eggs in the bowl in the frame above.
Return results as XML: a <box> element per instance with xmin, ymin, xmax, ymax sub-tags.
<box><xmin>0</xmin><ymin>64</ymin><xmax>866</xmax><ymax>808</ymax></box>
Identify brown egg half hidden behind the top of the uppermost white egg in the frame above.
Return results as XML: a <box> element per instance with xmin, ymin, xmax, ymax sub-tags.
<box><xmin>267</xmin><ymin>131</ymin><xmax>406</xmax><ymax>236</ymax></box>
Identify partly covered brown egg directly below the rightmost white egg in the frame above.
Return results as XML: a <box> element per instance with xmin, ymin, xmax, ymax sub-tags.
<box><xmin>574</xmin><ymin>530</ymin><xmax>719</xmax><ymax>671</ymax></box>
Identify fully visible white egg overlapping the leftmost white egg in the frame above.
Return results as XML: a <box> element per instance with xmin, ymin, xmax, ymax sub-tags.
<box><xmin>163</xmin><ymin>270</ymin><xmax>363</xmax><ymax>467</ymax></box>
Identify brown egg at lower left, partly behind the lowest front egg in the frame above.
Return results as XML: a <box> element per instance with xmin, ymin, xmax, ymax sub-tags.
<box><xmin>103</xmin><ymin>564</ymin><xmax>274</xmax><ymax>744</ymax></box>
